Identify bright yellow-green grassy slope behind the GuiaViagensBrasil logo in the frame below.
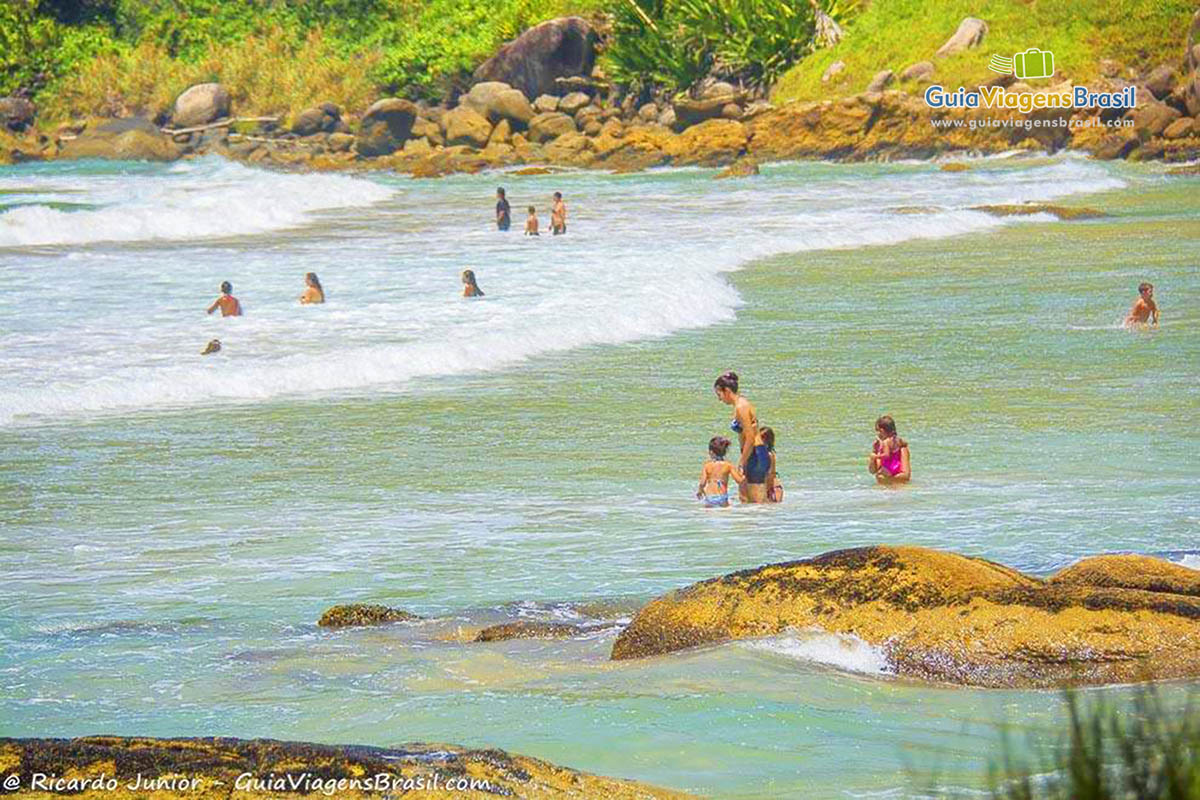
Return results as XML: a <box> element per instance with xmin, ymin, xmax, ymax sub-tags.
<box><xmin>774</xmin><ymin>0</ymin><xmax>1195</xmax><ymax>102</ymax></box>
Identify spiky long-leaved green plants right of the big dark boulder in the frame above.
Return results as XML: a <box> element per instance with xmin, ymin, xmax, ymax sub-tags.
<box><xmin>607</xmin><ymin>0</ymin><xmax>858</xmax><ymax>89</ymax></box>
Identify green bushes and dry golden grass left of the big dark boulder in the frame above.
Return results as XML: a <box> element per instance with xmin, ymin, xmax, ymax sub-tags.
<box><xmin>0</xmin><ymin>0</ymin><xmax>605</xmax><ymax>120</ymax></box>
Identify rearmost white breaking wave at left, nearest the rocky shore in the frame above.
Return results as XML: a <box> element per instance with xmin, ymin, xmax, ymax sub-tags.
<box><xmin>0</xmin><ymin>160</ymin><xmax>392</xmax><ymax>247</ymax></box>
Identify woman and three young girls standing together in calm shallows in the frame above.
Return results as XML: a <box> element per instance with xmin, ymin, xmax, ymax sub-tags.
<box><xmin>696</xmin><ymin>371</ymin><xmax>912</xmax><ymax>509</ymax></box>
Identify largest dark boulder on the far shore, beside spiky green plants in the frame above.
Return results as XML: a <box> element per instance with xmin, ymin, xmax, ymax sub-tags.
<box><xmin>475</xmin><ymin>17</ymin><xmax>598</xmax><ymax>100</ymax></box>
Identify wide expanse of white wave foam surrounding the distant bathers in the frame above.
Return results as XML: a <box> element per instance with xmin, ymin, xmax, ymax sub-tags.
<box><xmin>0</xmin><ymin>154</ymin><xmax>1121</xmax><ymax>425</ymax></box>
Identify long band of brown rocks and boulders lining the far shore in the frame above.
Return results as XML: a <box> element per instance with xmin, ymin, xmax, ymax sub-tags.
<box><xmin>0</xmin><ymin>12</ymin><xmax>1200</xmax><ymax>178</ymax></box>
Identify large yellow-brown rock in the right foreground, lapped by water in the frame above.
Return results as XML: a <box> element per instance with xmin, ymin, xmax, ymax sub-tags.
<box><xmin>612</xmin><ymin>546</ymin><xmax>1200</xmax><ymax>687</ymax></box>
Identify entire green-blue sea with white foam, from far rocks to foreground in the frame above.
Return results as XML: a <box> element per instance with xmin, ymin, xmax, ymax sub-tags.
<box><xmin>0</xmin><ymin>153</ymin><xmax>1200</xmax><ymax>798</ymax></box>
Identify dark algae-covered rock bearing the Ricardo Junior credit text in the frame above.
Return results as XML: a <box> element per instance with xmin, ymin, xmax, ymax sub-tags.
<box><xmin>0</xmin><ymin>736</ymin><xmax>690</xmax><ymax>800</ymax></box>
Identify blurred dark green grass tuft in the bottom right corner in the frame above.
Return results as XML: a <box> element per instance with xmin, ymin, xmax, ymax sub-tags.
<box><xmin>991</xmin><ymin>688</ymin><xmax>1200</xmax><ymax>800</ymax></box>
